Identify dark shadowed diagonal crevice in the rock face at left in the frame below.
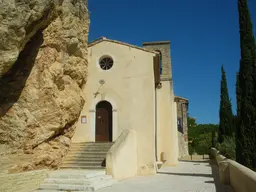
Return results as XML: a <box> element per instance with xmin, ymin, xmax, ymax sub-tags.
<box><xmin>0</xmin><ymin>30</ymin><xmax>43</xmax><ymax>117</ymax></box>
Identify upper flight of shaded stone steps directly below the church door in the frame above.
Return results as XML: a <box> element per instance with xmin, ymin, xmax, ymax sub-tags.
<box><xmin>60</xmin><ymin>143</ymin><xmax>113</xmax><ymax>170</ymax></box>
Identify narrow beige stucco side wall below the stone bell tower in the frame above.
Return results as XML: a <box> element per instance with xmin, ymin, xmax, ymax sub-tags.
<box><xmin>156</xmin><ymin>81</ymin><xmax>178</xmax><ymax>166</ymax></box>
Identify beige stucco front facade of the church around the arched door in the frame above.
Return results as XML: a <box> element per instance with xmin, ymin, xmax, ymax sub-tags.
<box><xmin>72</xmin><ymin>41</ymin><xmax>155</xmax><ymax>175</ymax></box>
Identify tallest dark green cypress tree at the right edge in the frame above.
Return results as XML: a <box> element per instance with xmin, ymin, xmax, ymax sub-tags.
<box><xmin>236</xmin><ymin>0</ymin><xmax>256</xmax><ymax>169</ymax></box>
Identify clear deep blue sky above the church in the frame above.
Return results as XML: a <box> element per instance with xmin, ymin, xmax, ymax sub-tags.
<box><xmin>89</xmin><ymin>0</ymin><xmax>256</xmax><ymax>123</ymax></box>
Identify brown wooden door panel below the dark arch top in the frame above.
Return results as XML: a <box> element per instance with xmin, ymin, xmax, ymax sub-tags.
<box><xmin>96</xmin><ymin>108</ymin><xmax>110</xmax><ymax>141</ymax></box>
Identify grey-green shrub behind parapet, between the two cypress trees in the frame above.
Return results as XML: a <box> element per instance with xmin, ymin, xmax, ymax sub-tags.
<box><xmin>219</xmin><ymin>136</ymin><xmax>236</xmax><ymax>160</ymax></box>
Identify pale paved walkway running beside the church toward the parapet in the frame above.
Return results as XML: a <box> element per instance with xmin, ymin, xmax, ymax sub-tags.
<box><xmin>99</xmin><ymin>161</ymin><xmax>232</xmax><ymax>192</ymax></box>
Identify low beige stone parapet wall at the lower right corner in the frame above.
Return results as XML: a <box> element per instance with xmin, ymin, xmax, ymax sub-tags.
<box><xmin>211</xmin><ymin>148</ymin><xmax>256</xmax><ymax>192</ymax></box>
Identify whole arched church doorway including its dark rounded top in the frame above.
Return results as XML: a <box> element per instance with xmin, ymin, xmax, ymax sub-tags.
<box><xmin>95</xmin><ymin>101</ymin><xmax>112</xmax><ymax>142</ymax></box>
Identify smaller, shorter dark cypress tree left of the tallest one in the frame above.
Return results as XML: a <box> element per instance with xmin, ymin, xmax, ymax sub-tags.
<box><xmin>218</xmin><ymin>65</ymin><xmax>233</xmax><ymax>143</ymax></box>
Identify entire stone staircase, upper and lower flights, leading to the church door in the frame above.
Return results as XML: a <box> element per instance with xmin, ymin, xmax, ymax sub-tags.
<box><xmin>37</xmin><ymin>143</ymin><xmax>116</xmax><ymax>192</ymax></box>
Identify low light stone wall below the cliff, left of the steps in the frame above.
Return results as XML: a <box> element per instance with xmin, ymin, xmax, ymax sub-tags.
<box><xmin>0</xmin><ymin>170</ymin><xmax>48</xmax><ymax>192</ymax></box>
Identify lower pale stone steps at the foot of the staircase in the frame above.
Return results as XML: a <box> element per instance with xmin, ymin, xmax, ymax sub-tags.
<box><xmin>36</xmin><ymin>169</ymin><xmax>117</xmax><ymax>192</ymax></box>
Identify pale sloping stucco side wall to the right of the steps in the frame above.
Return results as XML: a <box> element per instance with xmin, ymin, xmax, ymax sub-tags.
<box><xmin>106</xmin><ymin>129</ymin><xmax>138</xmax><ymax>180</ymax></box>
